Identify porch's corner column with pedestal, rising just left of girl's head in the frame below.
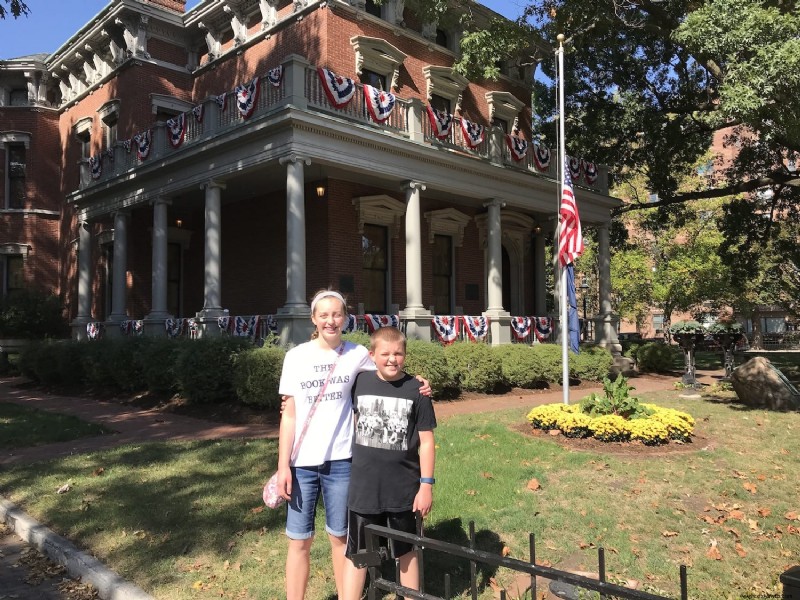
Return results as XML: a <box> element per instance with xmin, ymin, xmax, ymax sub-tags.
<box><xmin>276</xmin><ymin>154</ymin><xmax>312</xmax><ymax>345</ymax></box>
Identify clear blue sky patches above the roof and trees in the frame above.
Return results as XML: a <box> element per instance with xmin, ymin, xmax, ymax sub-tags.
<box><xmin>0</xmin><ymin>0</ymin><xmax>526</xmax><ymax>60</ymax></box>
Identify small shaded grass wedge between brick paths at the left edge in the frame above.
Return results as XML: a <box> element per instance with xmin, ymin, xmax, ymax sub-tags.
<box><xmin>0</xmin><ymin>402</ymin><xmax>110</xmax><ymax>448</ymax></box>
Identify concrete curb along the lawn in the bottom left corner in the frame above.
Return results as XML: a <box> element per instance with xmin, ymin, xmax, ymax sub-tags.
<box><xmin>0</xmin><ymin>496</ymin><xmax>155</xmax><ymax>600</ymax></box>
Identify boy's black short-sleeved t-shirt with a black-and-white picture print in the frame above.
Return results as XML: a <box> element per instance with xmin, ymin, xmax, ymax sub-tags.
<box><xmin>347</xmin><ymin>371</ymin><xmax>436</xmax><ymax>514</ymax></box>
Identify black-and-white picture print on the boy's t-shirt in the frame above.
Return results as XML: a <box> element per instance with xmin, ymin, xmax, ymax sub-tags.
<box><xmin>356</xmin><ymin>395</ymin><xmax>414</xmax><ymax>450</ymax></box>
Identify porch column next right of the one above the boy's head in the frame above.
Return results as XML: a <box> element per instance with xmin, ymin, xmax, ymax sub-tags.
<box><xmin>483</xmin><ymin>199</ymin><xmax>511</xmax><ymax>346</ymax></box>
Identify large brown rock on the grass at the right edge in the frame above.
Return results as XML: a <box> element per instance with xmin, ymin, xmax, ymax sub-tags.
<box><xmin>731</xmin><ymin>356</ymin><xmax>800</xmax><ymax>410</ymax></box>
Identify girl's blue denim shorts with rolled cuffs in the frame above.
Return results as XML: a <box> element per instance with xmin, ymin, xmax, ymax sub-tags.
<box><xmin>286</xmin><ymin>458</ymin><xmax>351</xmax><ymax>540</ymax></box>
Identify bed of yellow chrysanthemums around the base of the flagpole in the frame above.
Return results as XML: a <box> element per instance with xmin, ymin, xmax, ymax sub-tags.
<box><xmin>527</xmin><ymin>403</ymin><xmax>694</xmax><ymax>446</ymax></box>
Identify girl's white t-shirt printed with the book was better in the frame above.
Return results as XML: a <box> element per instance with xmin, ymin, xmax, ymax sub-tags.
<box><xmin>279</xmin><ymin>341</ymin><xmax>375</xmax><ymax>467</ymax></box>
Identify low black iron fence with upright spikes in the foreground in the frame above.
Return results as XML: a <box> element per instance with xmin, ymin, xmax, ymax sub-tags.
<box><xmin>354</xmin><ymin>521</ymin><xmax>688</xmax><ymax>600</ymax></box>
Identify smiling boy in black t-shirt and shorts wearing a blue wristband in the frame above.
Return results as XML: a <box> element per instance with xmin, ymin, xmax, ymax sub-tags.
<box><xmin>343</xmin><ymin>327</ymin><xmax>436</xmax><ymax>600</ymax></box>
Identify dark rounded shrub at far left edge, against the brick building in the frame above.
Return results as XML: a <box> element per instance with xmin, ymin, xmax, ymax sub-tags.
<box><xmin>0</xmin><ymin>290</ymin><xmax>69</xmax><ymax>340</ymax></box>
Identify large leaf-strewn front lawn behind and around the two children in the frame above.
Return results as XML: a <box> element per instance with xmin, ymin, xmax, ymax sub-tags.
<box><xmin>0</xmin><ymin>391</ymin><xmax>800</xmax><ymax>600</ymax></box>
